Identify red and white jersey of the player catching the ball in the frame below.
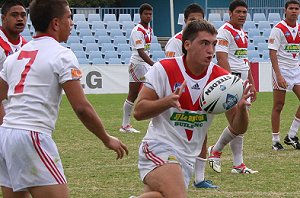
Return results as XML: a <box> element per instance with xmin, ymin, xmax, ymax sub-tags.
<box><xmin>144</xmin><ymin>56</ymin><xmax>228</xmax><ymax>159</ymax></box>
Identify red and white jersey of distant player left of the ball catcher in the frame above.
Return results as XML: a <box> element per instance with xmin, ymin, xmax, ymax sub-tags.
<box><xmin>130</xmin><ymin>24</ymin><xmax>153</xmax><ymax>64</ymax></box>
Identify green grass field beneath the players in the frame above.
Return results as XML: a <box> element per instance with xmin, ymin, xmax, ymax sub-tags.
<box><xmin>0</xmin><ymin>93</ymin><xmax>300</xmax><ymax>198</ymax></box>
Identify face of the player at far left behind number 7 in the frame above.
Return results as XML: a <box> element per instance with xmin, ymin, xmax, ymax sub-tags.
<box><xmin>2</xmin><ymin>5</ymin><xmax>27</xmax><ymax>36</ymax></box>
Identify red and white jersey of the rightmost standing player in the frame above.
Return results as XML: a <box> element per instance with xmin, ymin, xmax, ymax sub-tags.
<box><xmin>268</xmin><ymin>20</ymin><xmax>300</xmax><ymax>68</ymax></box>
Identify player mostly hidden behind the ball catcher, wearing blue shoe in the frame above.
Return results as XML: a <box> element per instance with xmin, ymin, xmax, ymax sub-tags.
<box><xmin>165</xmin><ymin>3</ymin><xmax>218</xmax><ymax>188</ymax></box>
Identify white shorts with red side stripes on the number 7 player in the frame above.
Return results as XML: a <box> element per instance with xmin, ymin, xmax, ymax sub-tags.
<box><xmin>0</xmin><ymin>127</ymin><xmax>67</xmax><ymax>192</ymax></box>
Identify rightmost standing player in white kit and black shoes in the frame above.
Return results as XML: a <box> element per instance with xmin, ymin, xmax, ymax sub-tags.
<box><xmin>268</xmin><ymin>0</ymin><xmax>300</xmax><ymax>150</ymax></box>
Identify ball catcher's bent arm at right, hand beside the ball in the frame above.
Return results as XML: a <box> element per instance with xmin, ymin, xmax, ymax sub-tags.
<box><xmin>225</xmin><ymin>80</ymin><xmax>253</xmax><ymax>135</ymax></box>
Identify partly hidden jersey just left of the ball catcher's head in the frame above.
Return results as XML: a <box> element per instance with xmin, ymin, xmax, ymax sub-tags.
<box><xmin>165</xmin><ymin>31</ymin><xmax>183</xmax><ymax>57</ymax></box>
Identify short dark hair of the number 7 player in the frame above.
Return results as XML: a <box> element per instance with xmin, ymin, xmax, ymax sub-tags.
<box><xmin>29</xmin><ymin>0</ymin><xmax>69</xmax><ymax>32</ymax></box>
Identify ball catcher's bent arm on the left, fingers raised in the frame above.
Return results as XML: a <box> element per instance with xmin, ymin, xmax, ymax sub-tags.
<box><xmin>133</xmin><ymin>82</ymin><xmax>186</xmax><ymax>120</ymax></box>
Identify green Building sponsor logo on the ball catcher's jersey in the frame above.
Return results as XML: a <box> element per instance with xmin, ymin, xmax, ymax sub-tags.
<box><xmin>170</xmin><ymin>111</ymin><xmax>207</xmax><ymax>129</ymax></box>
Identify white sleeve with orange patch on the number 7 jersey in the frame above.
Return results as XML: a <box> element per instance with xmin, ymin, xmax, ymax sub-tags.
<box><xmin>59</xmin><ymin>49</ymin><xmax>82</xmax><ymax>84</ymax></box>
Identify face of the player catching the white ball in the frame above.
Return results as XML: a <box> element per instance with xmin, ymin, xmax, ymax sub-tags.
<box><xmin>184</xmin><ymin>31</ymin><xmax>217</xmax><ymax>67</ymax></box>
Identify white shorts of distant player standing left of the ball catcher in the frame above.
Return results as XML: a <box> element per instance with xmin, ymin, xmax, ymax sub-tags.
<box><xmin>128</xmin><ymin>63</ymin><xmax>150</xmax><ymax>82</ymax></box>
